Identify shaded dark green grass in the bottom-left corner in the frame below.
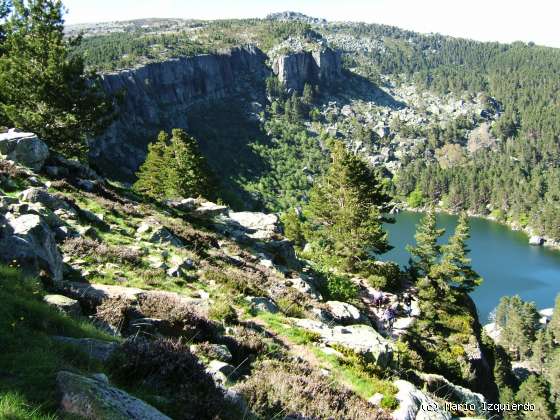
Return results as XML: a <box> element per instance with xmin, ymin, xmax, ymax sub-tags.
<box><xmin>0</xmin><ymin>266</ymin><xmax>115</xmax><ymax>419</ymax></box>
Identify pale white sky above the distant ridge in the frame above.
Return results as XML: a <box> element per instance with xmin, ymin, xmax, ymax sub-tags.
<box><xmin>63</xmin><ymin>0</ymin><xmax>560</xmax><ymax>48</ymax></box>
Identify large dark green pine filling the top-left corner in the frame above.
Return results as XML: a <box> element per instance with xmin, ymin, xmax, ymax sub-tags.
<box><xmin>0</xmin><ymin>0</ymin><xmax>112</xmax><ymax>156</ymax></box>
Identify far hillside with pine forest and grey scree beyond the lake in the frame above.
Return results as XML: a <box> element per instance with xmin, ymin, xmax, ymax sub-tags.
<box><xmin>71</xmin><ymin>14</ymin><xmax>560</xmax><ymax>246</ymax></box>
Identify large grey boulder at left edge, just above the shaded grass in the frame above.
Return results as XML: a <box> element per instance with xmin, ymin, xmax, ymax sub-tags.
<box><xmin>0</xmin><ymin>213</ymin><xmax>62</xmax><ymax>281</ymax></box>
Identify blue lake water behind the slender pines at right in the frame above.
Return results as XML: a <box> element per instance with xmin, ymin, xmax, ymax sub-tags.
<box><xmin>382</xmin><ymin>212</ymin><xmax>560</xmax><ymax>324</ymax></box>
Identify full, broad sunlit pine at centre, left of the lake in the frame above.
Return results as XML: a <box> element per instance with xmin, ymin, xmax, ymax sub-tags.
<box><xmin>307</xmin><ymin>142</ymin><xmax>391</xmax><ymax>271</ymax></box>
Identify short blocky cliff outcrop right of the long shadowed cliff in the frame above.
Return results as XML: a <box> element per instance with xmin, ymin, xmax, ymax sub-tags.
<box><xmin>273</xmin><ymin>48</ymin><xmax>342</xmax><ymax>90</ymax></box>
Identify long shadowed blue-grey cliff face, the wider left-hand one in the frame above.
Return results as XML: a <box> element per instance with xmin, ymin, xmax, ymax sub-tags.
<box><xmin>90</xmin><ymin>47</ymin><xmax>269</xmax><ymax>181</ymax></box>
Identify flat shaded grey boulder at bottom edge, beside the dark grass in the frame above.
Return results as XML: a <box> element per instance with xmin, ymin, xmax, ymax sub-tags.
<box><xmin>56</xmin><ymin>371</ymin><xmax>170</xmax><ymax>420</ymax></box>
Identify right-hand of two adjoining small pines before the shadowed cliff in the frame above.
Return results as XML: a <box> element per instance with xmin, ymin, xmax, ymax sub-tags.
<box><xmin>164</xmin><ymin>128</ymin><xmax>212</xmax><ymax>198</ymax></box>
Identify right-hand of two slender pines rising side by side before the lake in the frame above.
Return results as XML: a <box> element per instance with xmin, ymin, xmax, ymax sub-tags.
<box><xmin>438</xmin><ymin>213</ymin><xmax>482</xmax><ymax>293</ymax></box>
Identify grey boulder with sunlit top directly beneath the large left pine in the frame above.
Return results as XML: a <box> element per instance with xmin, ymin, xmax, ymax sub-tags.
<box><xmin>0</xmin><ymin>130</ymin><xmax>49</xmax><ymax>171</ymax></box>
